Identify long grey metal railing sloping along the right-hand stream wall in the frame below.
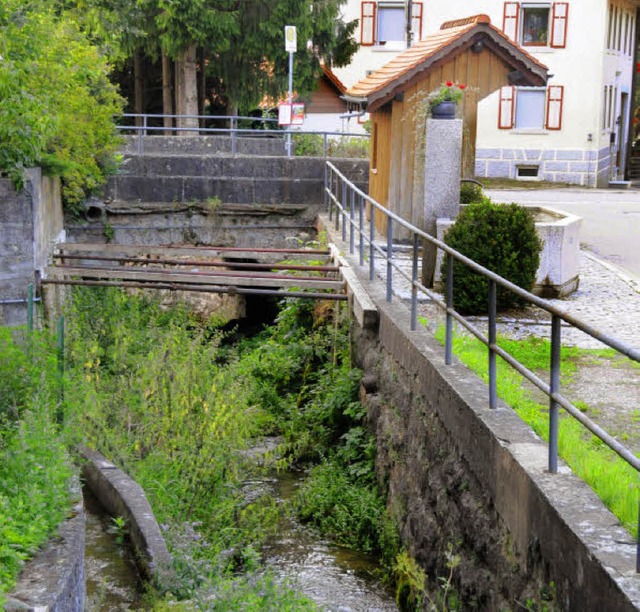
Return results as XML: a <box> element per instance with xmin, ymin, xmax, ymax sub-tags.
<box><xmin>325</xmin><ymin>162</ymin><xmax>640</xmax><ymax>573</ymax></box>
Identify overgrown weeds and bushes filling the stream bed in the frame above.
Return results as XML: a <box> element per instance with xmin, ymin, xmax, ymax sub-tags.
<box><xmin>55</xmin><ymin>289</ymin><xmax>394</xmax><ymax>609</ymax></box>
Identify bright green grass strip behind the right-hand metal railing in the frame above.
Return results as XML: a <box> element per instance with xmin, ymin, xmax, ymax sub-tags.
<box><xmin>436</xmin><ymin>327</ymin><xmax>640</xmax><ymax>538</ymax></box>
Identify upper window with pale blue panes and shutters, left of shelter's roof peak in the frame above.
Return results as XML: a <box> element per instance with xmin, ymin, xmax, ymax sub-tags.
<box><xmin>360</xmin><ymin>0</ymin><xmax>423</xmax><ymax>48</ymax></box>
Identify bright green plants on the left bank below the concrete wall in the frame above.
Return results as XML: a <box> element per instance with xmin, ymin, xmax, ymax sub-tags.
<box><xmin>0</xmin><ymin>328</ymin><xmax>73</xmax><ymax>599</ymax></box>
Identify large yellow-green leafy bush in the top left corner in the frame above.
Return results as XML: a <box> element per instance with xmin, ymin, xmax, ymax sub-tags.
<box><xmin>0</xmin><ymin>0</ymin><xmax>121</xmax><ymax>212</ymax></box>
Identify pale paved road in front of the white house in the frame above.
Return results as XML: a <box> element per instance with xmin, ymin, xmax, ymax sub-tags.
<box><xmin>486</xmin><ymin>189</ymin><xmax>640</xmax><ymax>279</ymax></box>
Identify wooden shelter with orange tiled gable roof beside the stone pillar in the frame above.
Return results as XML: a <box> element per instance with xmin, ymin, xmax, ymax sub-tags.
<box><xmin>345</xmin><ymin>15</ymin><xmax>548</xmax><ymax>229</ymax></box>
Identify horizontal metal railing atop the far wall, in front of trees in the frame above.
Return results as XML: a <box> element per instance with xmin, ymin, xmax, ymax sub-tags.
<box><xmin>116</xmin><ymin>113</ymin><xmax>369</xmax><ymax>158</ymax></box>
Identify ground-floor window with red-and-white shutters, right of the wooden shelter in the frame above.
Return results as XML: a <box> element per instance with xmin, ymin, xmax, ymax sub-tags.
<box><xmin>498</xmin><ymin>85</ymin><xmax>564</xmax><ymax>130</ymax></box>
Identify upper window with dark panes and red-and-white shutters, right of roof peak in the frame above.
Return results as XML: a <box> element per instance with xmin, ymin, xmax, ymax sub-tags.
<box><xmin>502</xmin><ymin>2</ymin><xmax>569</xmax><ymax>48</ymax></box>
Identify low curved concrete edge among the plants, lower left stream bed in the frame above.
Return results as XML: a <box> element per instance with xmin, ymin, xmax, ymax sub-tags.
<box><xmin>78</xmin><ymin>447</ymin><xmax>174</xmax><ymax>590</ymax></box>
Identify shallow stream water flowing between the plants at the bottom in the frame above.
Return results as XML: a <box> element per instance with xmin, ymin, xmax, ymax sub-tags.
<box><xmin>85</xmin><ymin>472</ymin><xmax>397</xmax><ymax>612</ymax></box>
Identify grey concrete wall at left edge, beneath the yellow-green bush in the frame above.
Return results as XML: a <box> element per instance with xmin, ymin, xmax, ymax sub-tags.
<box><xmin>0</xmin><ymin>168</ymin><xmax>64</xmax><ymax>325</ymax></box>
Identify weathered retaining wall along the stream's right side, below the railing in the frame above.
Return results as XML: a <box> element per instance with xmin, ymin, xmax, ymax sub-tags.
<box><xmin>326</xmin><ymin>218</ymin><xmax>640</xmax><ymax>611</ymax></box>
